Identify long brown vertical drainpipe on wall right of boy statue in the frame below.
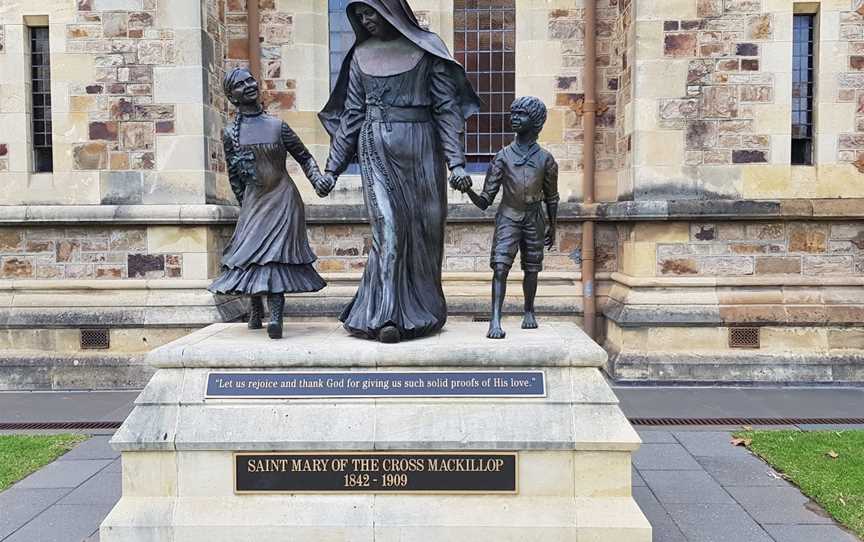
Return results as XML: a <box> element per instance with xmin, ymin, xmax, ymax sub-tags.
<box><xmin>582</xmin><ymin>0</ymin><xmax>597</xmax><ymax>339</ymax></box>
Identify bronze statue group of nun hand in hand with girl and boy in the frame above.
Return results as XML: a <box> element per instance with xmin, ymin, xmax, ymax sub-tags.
<box><xmin>210</xmin><ymin>0</ymin><xmax>558</xmax><ymax>343</ymax></box>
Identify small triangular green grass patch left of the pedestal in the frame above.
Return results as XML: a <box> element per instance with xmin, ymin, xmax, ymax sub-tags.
<box><xmin>0</xmin><ymin>435</ymin><xmax>87</xmax><ymax>491</ymax></box>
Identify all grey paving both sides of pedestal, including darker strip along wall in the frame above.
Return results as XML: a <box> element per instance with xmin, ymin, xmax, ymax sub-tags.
<box><xmin>0</xmin><ymin>387</ymin><xmax>864</xmax><ymax>542</ymax></box>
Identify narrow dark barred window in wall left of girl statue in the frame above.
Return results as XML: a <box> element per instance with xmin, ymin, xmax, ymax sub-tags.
<box><xmin>30</xmin><ymin>26</ymin><xmax>54</xmax><ymax>173</ymax></box>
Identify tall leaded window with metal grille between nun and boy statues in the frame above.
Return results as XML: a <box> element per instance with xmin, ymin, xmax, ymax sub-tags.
<box><xmin>453</xmin><ymin>0</ymin><xmax>516</xmax><ymax>170</ymax></box>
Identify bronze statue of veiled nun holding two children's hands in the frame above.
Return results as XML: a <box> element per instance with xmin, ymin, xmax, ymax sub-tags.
<box><xmin>319</xmin><ymin>0</ymin><xmax>480</xmax><ymax>343</ymax></box>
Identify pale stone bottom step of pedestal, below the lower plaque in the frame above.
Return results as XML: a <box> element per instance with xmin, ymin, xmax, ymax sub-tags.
<box><xmin>100</xmin><ymin>495</ymin><xmax>651</xmax><ymax>542</ymax></box>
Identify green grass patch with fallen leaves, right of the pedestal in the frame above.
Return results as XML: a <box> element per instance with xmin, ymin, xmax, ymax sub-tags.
<box><xmin>735</xmin><ymin>431</ymin><xmax>864</xmax><ymax>537</ymax></box>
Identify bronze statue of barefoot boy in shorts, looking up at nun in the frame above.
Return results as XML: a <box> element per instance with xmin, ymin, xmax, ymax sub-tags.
<box><xmin>452</xmin><ymin>96</ymin><xmax>559</xmax><ymax>339</ymax></box>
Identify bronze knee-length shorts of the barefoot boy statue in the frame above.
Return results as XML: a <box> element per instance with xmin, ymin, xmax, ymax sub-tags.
<box><xmin>489</xmin><ymin>209</ymin><xmax>546</xmax><ymax>273</ymax></box>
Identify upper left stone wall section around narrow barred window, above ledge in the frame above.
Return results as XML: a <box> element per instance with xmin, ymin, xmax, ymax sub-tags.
<box><xmin>0</xmin><ymin>0</ymin><xmax>227</xmax><ymax>205</ymax></box>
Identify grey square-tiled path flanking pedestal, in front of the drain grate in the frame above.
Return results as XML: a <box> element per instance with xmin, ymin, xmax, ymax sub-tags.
<box><xmin>0</xmin><ymin>430</ymin><xmax>858</xmax><ymax>542</ymax></box>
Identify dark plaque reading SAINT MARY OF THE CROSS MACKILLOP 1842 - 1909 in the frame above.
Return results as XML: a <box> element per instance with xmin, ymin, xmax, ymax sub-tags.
<box><xmin>234</xmin><ymin>452</ymin><xmax>518</xmax><ymax>493</ymax></box>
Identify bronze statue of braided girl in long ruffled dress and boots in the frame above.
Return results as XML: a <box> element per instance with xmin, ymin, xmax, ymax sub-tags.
<box><xmin>209</xmin><ymin>68</ymin><xmax>332</xmax><ymax>339</ymax></box>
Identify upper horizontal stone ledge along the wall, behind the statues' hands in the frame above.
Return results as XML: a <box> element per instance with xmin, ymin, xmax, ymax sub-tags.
<box><xmin>0</xmin><ymin>198</ymin><xmax>864</xmax><ymax>225</ymax></box>
